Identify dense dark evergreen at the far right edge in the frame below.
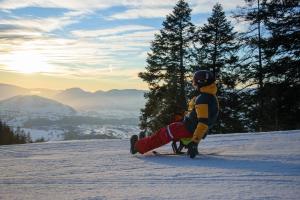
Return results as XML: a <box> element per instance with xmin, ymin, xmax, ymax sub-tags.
<box><xmin>263</xmin><ymin>0</ymin><xmax>300</xmax><ymax>130</ymax></box>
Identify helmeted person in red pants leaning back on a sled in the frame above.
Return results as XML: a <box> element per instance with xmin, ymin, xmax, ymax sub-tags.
<box><xmin>130</xmin><ymin>70</ymin><xmax>219</xmax><ymax>158</ymax></box>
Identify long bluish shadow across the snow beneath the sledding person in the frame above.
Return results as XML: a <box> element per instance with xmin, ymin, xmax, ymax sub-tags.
<box><xmin>136</xmin><ymin>153</ymin><xmax>300</xmax><ymax>176</ymax></box>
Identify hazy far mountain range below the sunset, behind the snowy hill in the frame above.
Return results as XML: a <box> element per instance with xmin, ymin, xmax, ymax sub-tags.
<box><xmin>0</xmin><ymin>84</ymin><xmax>145</xmax><ymax>115</ymax></box>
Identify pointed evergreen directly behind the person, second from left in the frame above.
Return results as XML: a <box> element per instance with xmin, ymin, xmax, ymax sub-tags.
<box><xmin>195</xmin><ymin>3</ymin><xmax>244</xmax><ymax>133</ymax></box>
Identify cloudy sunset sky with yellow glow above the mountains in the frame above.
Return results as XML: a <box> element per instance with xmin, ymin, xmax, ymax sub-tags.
<box><xmin>0</xmin><ymin>0</ymin><xmax>244</xmax><ymax>91</ymax></box>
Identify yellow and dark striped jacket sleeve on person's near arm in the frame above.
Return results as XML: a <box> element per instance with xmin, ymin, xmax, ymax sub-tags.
<box><xmin>192</xmin><ymin>96</ymin><xmax>209</xmax><ymax>143</ymax></box>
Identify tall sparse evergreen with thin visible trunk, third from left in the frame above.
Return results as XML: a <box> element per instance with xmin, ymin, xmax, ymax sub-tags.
<box><xmin>235</xmin><ymin>0</ymin><xmax>269</xmax><ymax>131</ymax></box>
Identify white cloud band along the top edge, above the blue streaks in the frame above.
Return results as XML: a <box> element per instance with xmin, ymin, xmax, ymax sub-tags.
<box><xmin>0</xmin><ymin>0</ymin><xmax>244</xmax><ymax>20</ymax></box>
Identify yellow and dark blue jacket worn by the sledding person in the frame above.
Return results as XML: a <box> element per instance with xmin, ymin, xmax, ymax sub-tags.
<box><xmin>183</xmin><ymin>83</ymin><xmax>219</xmax><ymax>143</ymax></box>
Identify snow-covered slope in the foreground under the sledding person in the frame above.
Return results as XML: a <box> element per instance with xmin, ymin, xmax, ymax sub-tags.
<box><xmin>0</xmin><ymin>130</ymin><xmax>300</xmax><ymax>200</ymax></box>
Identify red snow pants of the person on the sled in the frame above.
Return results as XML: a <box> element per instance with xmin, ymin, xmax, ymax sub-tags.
<box><xmin>134</xmin><ymin>122</ymin><xmax>193</xmax><ymax>154</ymax></box>
